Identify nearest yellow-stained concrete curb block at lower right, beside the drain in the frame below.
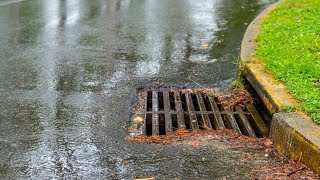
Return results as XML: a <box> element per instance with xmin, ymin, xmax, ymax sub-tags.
<box><xmin>270</xmin><ymin>113</ymin><xmax>320</xmax><ymax>174</ymax></box>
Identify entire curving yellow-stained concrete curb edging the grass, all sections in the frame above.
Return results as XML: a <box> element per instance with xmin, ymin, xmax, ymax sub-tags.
<box><xmin>240</xmin><ymin>0</ymin><xmax>320</xmax><ymax>174</ymax></box>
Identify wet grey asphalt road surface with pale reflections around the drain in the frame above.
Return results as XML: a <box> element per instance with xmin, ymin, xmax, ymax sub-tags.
<box><xmin>0</xmin><ymin>0</ymin><xmax>274</xmax><ymax>179</ymax></box>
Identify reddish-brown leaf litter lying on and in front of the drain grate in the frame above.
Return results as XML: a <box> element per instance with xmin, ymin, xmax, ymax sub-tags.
<box><xmin>127</xmin><ymin>89</ymin><xmax>320</xmax><ymax>180</ymax></box>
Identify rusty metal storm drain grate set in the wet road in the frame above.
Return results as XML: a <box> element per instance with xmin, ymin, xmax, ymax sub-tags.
<box><xmin>135</xmin><ymin>89</ymin><xmax>269</xmax><ymax>137</ymax></box>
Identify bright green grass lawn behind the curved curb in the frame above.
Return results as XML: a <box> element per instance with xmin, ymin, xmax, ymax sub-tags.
<box><xmin>256</xmin><ymin>0</ymin><xmax>320</xmax><ymax>124</ymax></box>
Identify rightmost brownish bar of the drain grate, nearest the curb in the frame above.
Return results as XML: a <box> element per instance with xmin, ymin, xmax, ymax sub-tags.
<box><xmin>247</xmin><ymin>103</ymin><xmax>269</xmax><ymax>137</ymax></box>
